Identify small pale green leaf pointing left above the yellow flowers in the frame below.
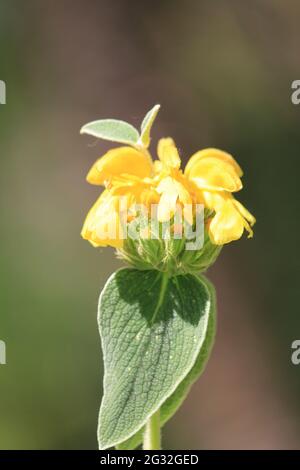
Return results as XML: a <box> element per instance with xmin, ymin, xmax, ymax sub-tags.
<box><xmin>80</xmin><ymin>119</ymin><xmax>139</xmax><ymax>145</ymax></box>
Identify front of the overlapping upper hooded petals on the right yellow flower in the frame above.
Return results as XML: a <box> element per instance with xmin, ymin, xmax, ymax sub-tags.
<box><xmin>185</xmin><ymin>157</ymin><xmax>242</xmax><ymax>192</ymax></box>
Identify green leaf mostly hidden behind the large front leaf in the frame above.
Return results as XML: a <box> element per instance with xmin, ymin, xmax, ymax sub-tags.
<box><xmin>117</xmin><ymin>276</ymin><xmax>216</xmax><ymax>450</ymax></box>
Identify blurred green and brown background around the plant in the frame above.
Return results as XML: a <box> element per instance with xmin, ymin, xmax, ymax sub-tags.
<box><xmin>0</xmin><ymin>0</ymin><xmax>300</xmax><ymax>449</ymax></box>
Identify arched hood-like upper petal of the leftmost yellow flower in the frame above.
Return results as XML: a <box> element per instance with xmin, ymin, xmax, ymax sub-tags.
<box><xmin>87</xmin><ymin>147</ymin><xmax>153</xmax><ymax>185</ymax></box>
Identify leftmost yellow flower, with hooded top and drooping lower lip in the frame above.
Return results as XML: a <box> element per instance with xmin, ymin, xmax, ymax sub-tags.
<box><xmin>81</xmin><ymin>147</ymin><xmax>159</xmax><ymax>248</ymax></box>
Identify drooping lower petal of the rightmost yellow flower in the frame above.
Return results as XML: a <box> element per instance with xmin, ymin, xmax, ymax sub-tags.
<box><xmin>209</xmin><ymin>200</ymin><xmax>244</xmax><ymax>245</ymax></box>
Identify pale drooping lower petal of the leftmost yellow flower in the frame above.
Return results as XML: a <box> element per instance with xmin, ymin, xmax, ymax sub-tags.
<box><xmin>81</xmin><ymin>190</ymin><xmax>124</xmax><ymax>248</ymax></box>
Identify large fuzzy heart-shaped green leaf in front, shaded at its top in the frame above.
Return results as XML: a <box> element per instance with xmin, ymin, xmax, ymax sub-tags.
<box><xmin>98</xmin><ymin>269</ymin><xmax>213</xmax><ymax>449</ymax></box>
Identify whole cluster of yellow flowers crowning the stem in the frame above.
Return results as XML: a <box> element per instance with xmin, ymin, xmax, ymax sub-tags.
<box><xmin>81</xmin><ymin>104</ymin><xmax>255</xmax><ymax>270</ymax></box>
